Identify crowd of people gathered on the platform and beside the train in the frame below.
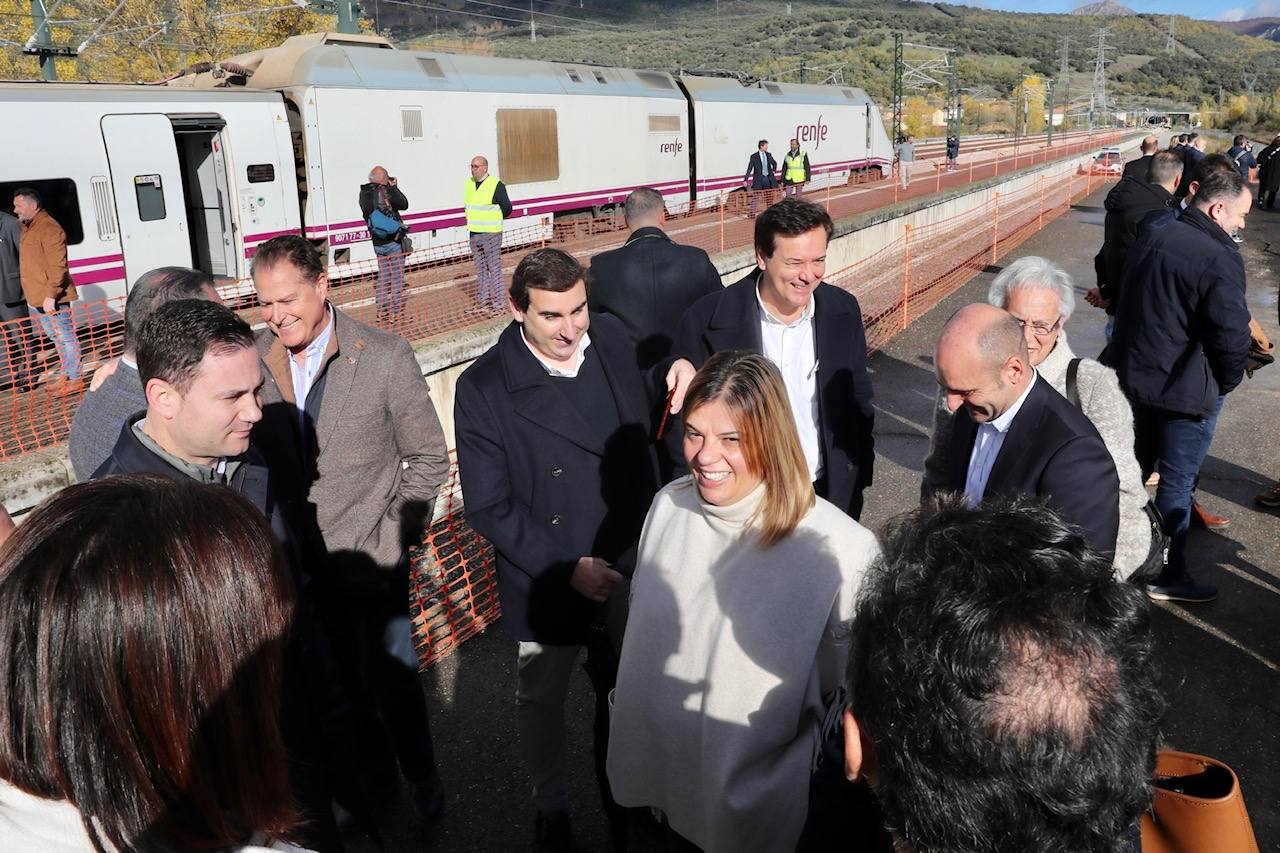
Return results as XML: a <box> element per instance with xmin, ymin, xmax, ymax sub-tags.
<box><xmin>0</xmin><ymin>126</ymin><xmax>1265</xmax><ymax>853</ymax></box>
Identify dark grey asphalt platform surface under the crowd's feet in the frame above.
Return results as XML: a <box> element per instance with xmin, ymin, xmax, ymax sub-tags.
<box><xmin>349</xmin><ymin>180</ymin><xmax>1280</xmax><ymax>853</ymax></box>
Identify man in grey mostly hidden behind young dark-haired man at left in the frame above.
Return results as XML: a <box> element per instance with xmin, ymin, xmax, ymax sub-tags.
<box><xmin>68</xmin><ymin>266</ymin><xmax>221</xmax><ymax>480</ymax></box>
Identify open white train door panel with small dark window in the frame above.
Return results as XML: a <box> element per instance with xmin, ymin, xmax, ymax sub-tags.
<box><xmin>102</xmin><ymin>114</ymin><xmax>191</xmax><ymax>282</ymax></box>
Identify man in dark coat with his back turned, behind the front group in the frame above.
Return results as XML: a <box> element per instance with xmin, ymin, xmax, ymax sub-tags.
<box><xmin>588</xmin><ymin>187</ymin><xmax>721</xmax><ymax>370</ymax></box>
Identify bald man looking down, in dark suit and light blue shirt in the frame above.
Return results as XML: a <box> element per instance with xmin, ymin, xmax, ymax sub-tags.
<box><xmin>927</xmin><ymin>305</ymin><xmax>1120</xmax><ymax>560</ymax></box>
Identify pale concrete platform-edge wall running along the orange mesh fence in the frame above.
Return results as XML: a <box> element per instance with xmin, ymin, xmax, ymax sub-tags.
<box><xmin>0</xmin><ymin>136</ymin><xmax>1140</xmax><ymax>515</ymax></box>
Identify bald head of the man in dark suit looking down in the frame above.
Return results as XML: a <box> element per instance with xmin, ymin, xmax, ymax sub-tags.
<box><xmin>933</xmin><ymin>304</ymin><xmax>1036</xmax><ymax>423</ymax></box>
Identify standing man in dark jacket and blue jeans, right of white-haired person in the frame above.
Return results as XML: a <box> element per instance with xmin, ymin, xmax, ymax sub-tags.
<box><xmin>1105</xmin><ymin>170</ymin><xmax>1253</xmax><ymax>602</ymax></box>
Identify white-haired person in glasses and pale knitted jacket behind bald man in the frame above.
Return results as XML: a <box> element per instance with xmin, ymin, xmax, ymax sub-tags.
<box><xmin>922</xmin><ymin>256</ymin><xmax>1161</xmax><ymax>578</ymax></box>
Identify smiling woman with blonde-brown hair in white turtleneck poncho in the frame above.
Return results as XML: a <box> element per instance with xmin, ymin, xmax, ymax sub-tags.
<box><xmin>608</xmin><ymin>351</ymin><xmax>877</xmax><ymax>853</ymax></box>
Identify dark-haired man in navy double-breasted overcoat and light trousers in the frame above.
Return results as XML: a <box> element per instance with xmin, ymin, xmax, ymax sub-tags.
<box><xmin>453</xmin><ymin>248</ymin><xmax>694</xmax><ymax>853</ymax></box>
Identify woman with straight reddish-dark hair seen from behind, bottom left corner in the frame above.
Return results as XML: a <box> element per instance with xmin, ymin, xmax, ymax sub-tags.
<box><xmin>0</xmin><ymin>475</ymin><xmax>309</xmax><ymax>853</ymax></box>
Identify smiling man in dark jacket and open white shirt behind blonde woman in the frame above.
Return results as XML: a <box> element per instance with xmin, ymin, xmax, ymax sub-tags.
<box><xmin>672</xmin><ymin>199</ymin><xmax>876</xmax><ymax>519</ymax></box>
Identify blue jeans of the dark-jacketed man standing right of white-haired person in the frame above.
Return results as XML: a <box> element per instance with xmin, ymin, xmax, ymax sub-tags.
<box><xmin>1133</xmin><ymin>397</ymin><xmax>1222</xmax><ymax>585</ymax></box>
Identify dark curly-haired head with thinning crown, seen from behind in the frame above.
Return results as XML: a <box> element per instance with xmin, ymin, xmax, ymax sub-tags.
<box><xmin>844</xmin><ymin>498</ymin><xmax>1165</xmax><ymax>853</ymax></box>
